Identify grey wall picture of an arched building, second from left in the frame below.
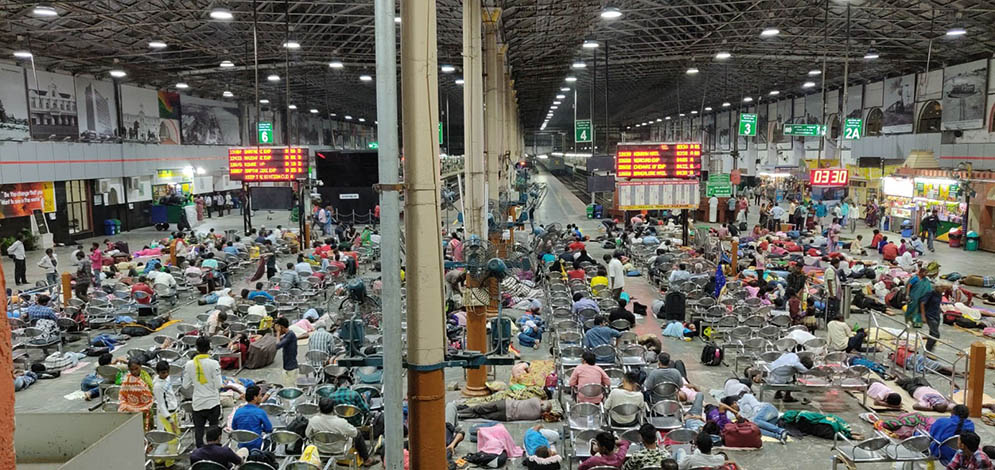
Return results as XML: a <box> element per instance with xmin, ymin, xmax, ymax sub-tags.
<box><xmin>28</xmin><ymin>70</ymin><xmax>78</xmax><ymax>140</ymax></box>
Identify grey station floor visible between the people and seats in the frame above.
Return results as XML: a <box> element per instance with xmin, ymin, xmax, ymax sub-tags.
<box><xmin>11</xmin><ymin>173</ymin><xmax>995</xmax><ymax>470</ymax></box>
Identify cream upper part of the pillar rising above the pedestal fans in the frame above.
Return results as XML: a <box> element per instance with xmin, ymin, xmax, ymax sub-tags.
<box><xmin>463</xmin><ymin>1</ymin><xmax>487</xmax><ymax>238</ymax></box>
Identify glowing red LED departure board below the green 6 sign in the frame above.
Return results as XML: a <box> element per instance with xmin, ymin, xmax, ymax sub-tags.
<box><xmin>228</xmin><ymin>147</ymin><xmax>307</xmax><ymax>182</ymax></box>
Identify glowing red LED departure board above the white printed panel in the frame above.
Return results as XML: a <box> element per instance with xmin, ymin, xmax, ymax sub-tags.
<box><xmin>615</xmin><ymin>143</ymin><xmax>701</xmax><ymax>179</ymax></box>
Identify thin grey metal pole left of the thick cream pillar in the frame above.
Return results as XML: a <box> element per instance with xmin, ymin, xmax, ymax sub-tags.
<box><xmin>374</xmin><ymin>0</ymin><xmax>404</xmax><ymax>470</ymax></box>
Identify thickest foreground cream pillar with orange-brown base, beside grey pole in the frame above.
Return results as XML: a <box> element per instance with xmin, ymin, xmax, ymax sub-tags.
<box><xmin>400</xmin><ymin>2</ymin><xmax>446</xmax><ymax>470</ymax></box>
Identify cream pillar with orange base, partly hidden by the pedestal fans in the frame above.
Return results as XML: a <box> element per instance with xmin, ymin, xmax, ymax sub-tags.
<box><xmin>463</xmin><ymin>0</ymin><xmax>490</xmax><ymax>396</ymax></box>
